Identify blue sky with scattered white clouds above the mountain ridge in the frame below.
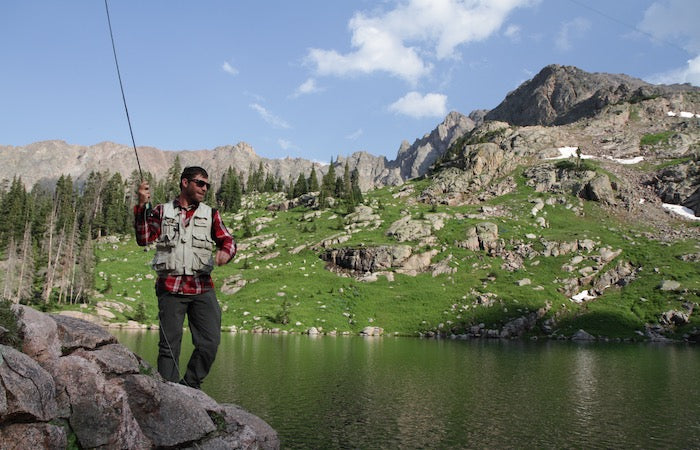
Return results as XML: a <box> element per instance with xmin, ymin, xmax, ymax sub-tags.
<box><xmin>0</xmin><ymin>0</ymin><xmax>700</xmax><ymax>162</ymax></box>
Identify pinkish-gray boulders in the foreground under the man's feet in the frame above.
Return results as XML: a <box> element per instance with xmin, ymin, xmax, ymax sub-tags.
<box><xmin>0</xmin><ymin>306</ymin><xmax>279</xmax><ymax>449</ymax></box>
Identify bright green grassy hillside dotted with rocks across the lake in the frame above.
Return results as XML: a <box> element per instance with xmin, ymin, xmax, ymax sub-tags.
<box><xmin>82</xmin><ymin>168</ymin><xmax>700</xmax><ymax>339</ymax></box>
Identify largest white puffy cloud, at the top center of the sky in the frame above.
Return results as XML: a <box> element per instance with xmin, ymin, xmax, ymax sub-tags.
<box><xmin>307</xmin><ymin>0</ymin><xmax>538</xmax><ymax>84</ymax></box>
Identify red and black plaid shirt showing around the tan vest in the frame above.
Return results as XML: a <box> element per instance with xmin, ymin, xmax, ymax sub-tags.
<box><xmin>134</xmin><ymin>199</ymin><xmax>236</xmax><ymax>295</ymax></box>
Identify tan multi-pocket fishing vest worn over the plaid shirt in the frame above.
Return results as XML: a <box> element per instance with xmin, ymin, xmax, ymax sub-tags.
<box><xmin>151</xmin><ymin>202</ymin><xmax>214</xmax><ymax>276</ymax></box>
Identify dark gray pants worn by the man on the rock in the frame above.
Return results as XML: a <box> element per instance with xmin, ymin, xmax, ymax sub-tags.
<box><xmin>156</xmin><ymin>289</ymin><xmax>221</xmax><ymax>389</ymax></box>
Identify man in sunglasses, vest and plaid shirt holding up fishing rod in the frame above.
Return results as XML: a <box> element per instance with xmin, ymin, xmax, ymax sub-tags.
<box><xmin>134</xmin><ymin>167</ymin><xmax>236</xmax><ymax>389</ymax></box>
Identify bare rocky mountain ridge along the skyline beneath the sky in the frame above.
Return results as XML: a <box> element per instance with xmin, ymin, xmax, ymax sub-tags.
<box><xmin>0</xmin><ymin>65</ymin><xmax>700</xmax><ymax>205</ymax></box>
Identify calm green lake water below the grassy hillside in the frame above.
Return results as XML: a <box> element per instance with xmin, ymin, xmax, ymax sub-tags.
<box><xmin>112</xmin><ymin>330</ymin><xmax>700</xmax><ymax>449</ymax></box>
